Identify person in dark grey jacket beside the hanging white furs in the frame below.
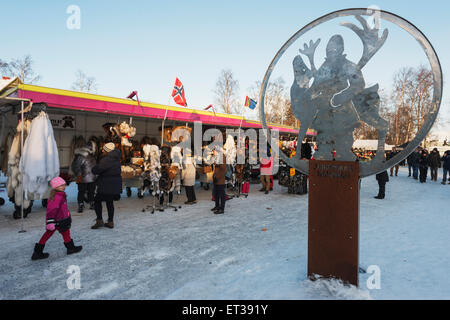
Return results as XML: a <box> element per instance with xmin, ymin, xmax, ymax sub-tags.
<box><xmin>71</xmin><ymin>146</ymin><xmax>97</xmax><ymax>212</ymax></box>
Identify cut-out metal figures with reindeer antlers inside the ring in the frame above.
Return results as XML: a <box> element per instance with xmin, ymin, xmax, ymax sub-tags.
<box><xmin>291</xmin><ymin>15</ymin><xmax>388</xmax><ymax>161</ymax></box>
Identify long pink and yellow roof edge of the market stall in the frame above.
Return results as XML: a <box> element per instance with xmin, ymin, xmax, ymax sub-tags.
<box><xmin>17</xmin><ymin>84</ymin><xmax>298</xmax><ymax>134</ymax></box>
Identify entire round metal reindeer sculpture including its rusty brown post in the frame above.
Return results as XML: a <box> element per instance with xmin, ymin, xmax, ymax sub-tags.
<box><xmin>259</xmin><ymin>9</ymin><xmax>442</xmax><ymax>285</ymax></box>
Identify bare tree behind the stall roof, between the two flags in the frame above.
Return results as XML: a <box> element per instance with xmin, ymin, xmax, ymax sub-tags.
<box><xmin>214</xmin><ymin>69</ymin><xmax>240</xmax><ymax>114</ymax></box>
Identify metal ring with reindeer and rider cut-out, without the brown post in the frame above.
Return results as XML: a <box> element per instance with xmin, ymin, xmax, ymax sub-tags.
<box><xmin>259</xmin><ymin>9</ymin><xmax>442</xmax><ymax>177</ymax></box>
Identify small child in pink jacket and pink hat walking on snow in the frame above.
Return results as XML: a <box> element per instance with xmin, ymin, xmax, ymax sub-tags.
<box><xmin>31</xmin><ymin>177</ymin><xmax>83</xmax><ymax>260</ymax></box>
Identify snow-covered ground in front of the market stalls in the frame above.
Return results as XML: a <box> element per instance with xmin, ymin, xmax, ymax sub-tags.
<box><xmin>0</xmin><ymin>168</ymin><xmax>450</xmax><ymax>299</ymax></box>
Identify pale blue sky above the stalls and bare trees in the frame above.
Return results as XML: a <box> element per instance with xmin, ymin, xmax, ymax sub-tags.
<box><xmin>0</xmin><ymin>0</ymin><xmax>450</xmax><ymax>127</ymax></box>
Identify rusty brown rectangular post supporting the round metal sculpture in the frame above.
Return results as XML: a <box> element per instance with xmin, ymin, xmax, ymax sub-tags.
<box><xmin>308</xmin><ymin>160</ymin><xmax>359</xmax><ymax>286</ymax></box>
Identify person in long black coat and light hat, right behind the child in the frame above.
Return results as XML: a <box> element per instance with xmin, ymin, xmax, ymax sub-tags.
<box><xmin>92</xmin><ymin>142</ymin><xmax>122</xmax><ymax>229</ymax></box>
